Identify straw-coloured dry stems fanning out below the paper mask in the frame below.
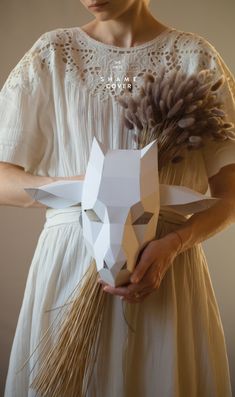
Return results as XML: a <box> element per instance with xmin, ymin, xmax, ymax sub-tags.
<box><xmin>30</xmin><ymin>260</ymin><xmax>106</xmax><ymax>397</ymax></box>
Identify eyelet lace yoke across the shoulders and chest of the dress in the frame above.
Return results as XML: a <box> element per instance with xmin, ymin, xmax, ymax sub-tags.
<box><xmin>2</xmin><ymin>27</ymin><xmax>222</xmax><ymax>100</ymax></box>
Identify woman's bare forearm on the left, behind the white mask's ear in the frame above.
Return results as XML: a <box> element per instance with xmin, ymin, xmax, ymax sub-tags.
<box><xmin>0</xmin><ymin>164</ymin><xmax>82</xmax><ymax>208</ymax></box>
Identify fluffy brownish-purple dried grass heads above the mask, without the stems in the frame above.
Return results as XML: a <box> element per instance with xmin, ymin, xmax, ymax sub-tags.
<box><xmin>118</xmin><ymin>68</ymin><xmax>235</xmax><ymax>169</ymax></box>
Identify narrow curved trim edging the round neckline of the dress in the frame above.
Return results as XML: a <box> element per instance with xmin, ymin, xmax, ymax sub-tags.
<box><xmin>77</xmin><ymin>26</ymin><xmax>176</xmax><ymax>52</ymax></box>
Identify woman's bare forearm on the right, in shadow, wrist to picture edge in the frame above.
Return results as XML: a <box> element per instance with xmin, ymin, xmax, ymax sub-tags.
<box><xmin>169</xmin><ymin>198</ymin><xmax>235</xmax><ymax>253</ymax></box>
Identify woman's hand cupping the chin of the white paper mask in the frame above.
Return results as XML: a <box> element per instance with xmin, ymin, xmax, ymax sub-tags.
<box><xmin>98</xmin><ymin>232</ymin><xmax>181</xmax><ymax>302</ymax></box>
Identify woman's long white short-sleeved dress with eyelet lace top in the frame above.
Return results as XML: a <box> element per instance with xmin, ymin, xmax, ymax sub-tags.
<box><xmin>0</xmin><ymin>27</ymin><xmax>235</xmax><ymax>397</ymax></box>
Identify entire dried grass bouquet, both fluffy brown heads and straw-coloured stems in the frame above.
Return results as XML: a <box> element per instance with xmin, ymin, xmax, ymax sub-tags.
<box><xmin>19</xmin><ymin>69</ymin><xmax>235</xmax><ymax>397</ymax></box>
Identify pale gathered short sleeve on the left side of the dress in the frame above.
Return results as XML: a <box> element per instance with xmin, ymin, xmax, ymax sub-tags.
<box><xmin>0</xmin><ymin>36</ymin><xmax>49</xmax><ymax>171</ymax></box>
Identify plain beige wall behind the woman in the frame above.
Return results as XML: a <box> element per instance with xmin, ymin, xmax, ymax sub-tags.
<box><xmin>0</xmin><ymin>0</ymin><xmax>235</xmax><ymax>397</ymax></box>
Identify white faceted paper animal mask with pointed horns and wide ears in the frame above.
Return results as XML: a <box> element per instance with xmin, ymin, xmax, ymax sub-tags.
<box><xmin>25</xmin><ymin>138</ymin><xmax>219</xmax><ymax>286</ymax></box>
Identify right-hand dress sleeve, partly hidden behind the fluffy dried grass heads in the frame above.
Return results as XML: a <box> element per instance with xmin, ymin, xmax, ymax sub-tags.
<box><xmin>199</xmin><ymin>39</ymin><xmax>235</xmax><ymax>178</ymax></box>
